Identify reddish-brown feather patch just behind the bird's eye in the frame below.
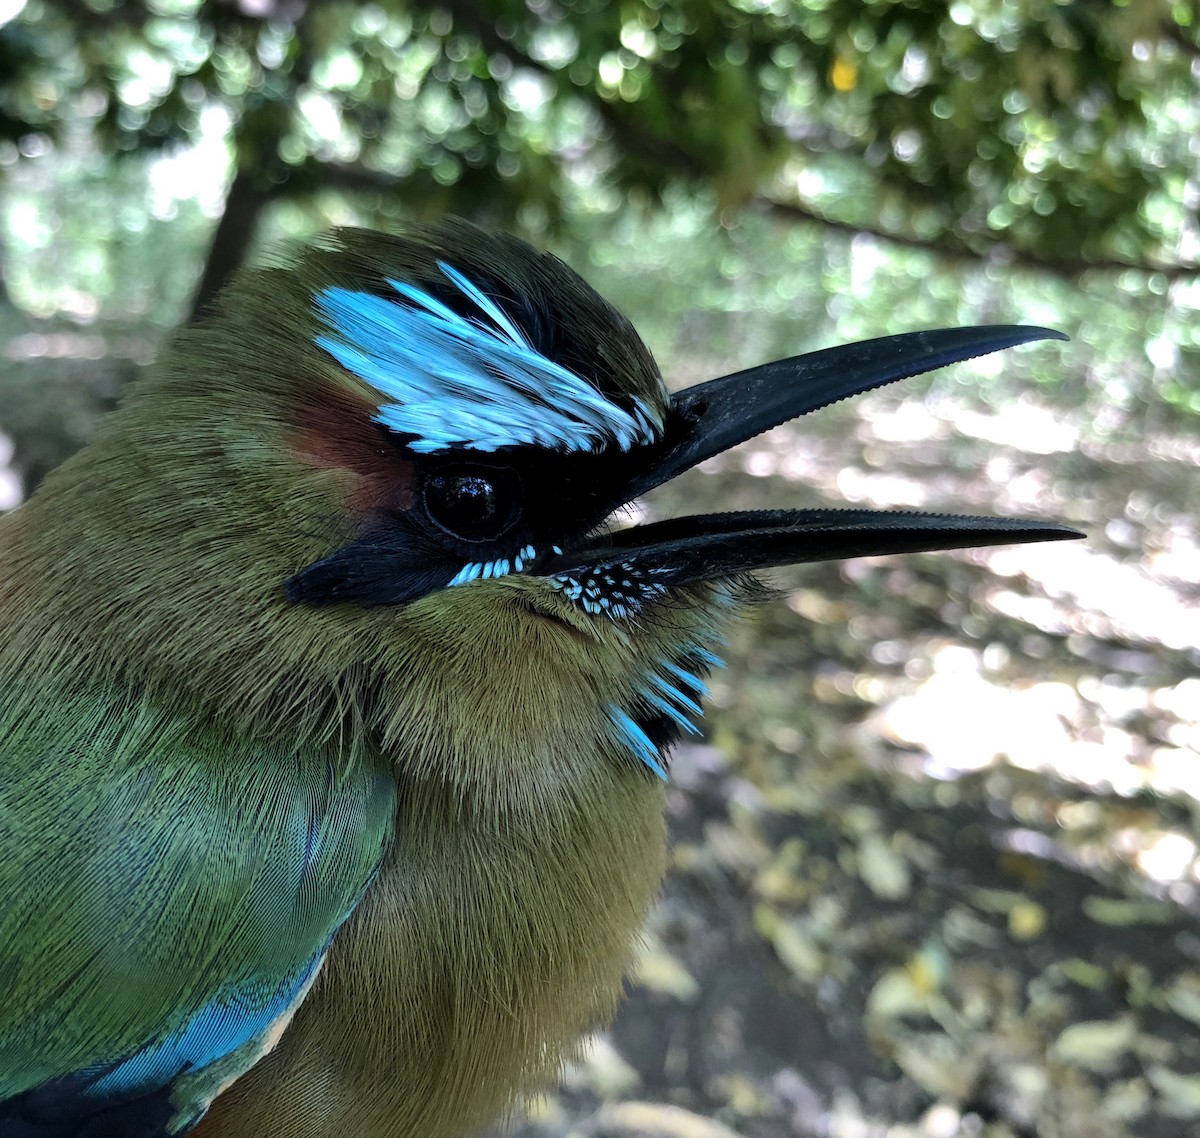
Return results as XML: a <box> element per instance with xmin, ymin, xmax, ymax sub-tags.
<box><xmin>294</xmin><ymin>383</ymin><xmax>416</xmax><ymax>515</ymax></box>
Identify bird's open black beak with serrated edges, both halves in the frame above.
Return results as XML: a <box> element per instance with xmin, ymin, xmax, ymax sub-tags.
<box><xmin>549</xmin><ymin>325</ymin><xmax>1082</xmax><ymax>586</ymax></box>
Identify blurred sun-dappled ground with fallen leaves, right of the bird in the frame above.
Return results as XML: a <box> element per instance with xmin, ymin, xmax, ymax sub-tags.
<box><xmin>487</xmin><ymin>381</ymin><xmax>1200</xmax><ymax>1138</ymax></box>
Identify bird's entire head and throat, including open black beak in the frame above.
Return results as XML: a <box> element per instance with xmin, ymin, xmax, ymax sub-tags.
<box><xmin>21</xmin><ymin>222</ymin><xmax>1076</xmax><ymax>779</ymax></box>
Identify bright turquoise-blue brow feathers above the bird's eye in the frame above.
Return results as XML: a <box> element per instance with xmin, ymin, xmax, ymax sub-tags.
<box><xmin>314</xmin><ymin>260</ymin><xmax>662</xmax><ymax>453</ymax></box>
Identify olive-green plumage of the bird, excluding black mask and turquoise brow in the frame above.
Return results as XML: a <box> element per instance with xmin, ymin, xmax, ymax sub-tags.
<box><xmin>0</xmin><ymin>229</ymin><xmax>713</xmax><ymax>1138</ymax></box>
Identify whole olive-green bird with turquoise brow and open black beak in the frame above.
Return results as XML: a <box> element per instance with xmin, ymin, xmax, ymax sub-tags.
<box><xmin>0</xmin><ymin>220</ymin><xmax>1078</xmax><ymax>1138</ymax></box>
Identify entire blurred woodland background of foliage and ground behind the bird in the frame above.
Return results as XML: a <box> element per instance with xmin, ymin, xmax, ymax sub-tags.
<box><xmin>0</xmin><ymin>0</ymin><xmax>1200</xmax><ymax>1138</ymax></box>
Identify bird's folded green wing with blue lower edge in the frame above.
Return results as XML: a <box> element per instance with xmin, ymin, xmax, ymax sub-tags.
<box><xmin>0</xmin><ymin>681</ymin><xmax>395</xmax><ymax>1136</ymax></box>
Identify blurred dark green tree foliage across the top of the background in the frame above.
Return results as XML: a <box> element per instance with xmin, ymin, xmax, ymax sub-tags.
<box><xmin>0</xmin><ymin>0</ymin><xmax>1200</xmax><ymax>282</ymax></box>
